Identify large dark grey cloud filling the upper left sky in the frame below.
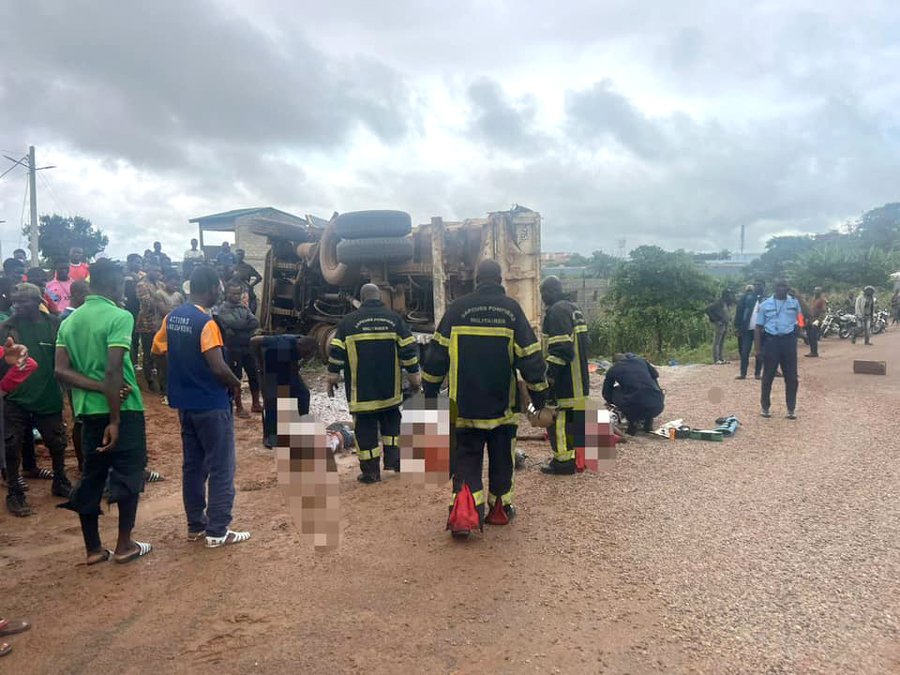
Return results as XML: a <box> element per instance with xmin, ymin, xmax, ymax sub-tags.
<box><xmin>0</xmin><ymin>0</ymin><xmax>411</xmax><ymax>167</ymax></box>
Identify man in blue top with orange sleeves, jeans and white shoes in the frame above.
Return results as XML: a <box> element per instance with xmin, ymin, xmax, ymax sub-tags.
<box><xmin>153</xmin><ymin>267</ymin><xmax>250</xmax><ymax>548</ymax></box>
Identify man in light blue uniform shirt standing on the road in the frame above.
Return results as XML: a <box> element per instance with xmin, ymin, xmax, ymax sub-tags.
<box><xmin>755</xmin><ymin>279</ymin><xmax>803</xmax><ymax>420</ymax></box>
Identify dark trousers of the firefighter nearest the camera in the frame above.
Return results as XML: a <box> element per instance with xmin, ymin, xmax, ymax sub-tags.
<box><xmin>451</xmin><ymin>424</ymin><xmax>517</xmax><ymax>520</ymax></box>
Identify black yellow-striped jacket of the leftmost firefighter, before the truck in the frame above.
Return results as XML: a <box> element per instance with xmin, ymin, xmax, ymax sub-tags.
<box><xmin>328</xmin><ymin>300</ymin><xmax>419</xmax><ymax>413</ymax></box>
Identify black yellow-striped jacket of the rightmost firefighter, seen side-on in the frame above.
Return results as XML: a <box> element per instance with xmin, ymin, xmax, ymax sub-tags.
<box><xmin>543</xmin><ymin>300</ymin><xmax>591</xmax><ymax>408</ymax></box>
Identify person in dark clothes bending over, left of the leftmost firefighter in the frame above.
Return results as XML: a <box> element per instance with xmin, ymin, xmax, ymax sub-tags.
<box><xmin>250</xmin><ymin>335</ymin><xmax>316</xmax><ymax>449</ymax></box>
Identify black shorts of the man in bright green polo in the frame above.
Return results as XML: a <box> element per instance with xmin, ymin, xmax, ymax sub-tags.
<box><xmin>59</xmin><ymin>411</ymin><xmax>147</xmax><ymax>515</ymax></box>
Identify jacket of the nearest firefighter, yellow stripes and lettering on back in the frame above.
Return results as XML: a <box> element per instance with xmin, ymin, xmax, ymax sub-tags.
<box><xmin>422</xmin><ymin>283</ymin><xmax>547</xmax><ymax>429</ymax></box>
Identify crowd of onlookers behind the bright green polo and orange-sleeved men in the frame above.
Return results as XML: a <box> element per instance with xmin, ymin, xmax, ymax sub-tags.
<box><xmin>0</xmin><ymin>239</ymin><xmax>262</xmax><ymax>516</ymax></box>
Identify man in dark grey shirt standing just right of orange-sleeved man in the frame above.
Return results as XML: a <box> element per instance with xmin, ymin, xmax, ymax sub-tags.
<box><xmin>214</xmin><ymin>279</ymin><xmax>263</xmax><ymax>418</ymax></box>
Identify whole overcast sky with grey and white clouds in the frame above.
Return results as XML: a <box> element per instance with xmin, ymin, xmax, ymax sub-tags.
<box><xmin>0</xmin><ymin>0</ymin><xmax>900</xmax><ymax>255</ymax></box>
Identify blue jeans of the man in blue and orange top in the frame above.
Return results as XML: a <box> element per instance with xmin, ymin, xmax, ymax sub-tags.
<box><xmin>178</xmin><ymin>408</ymin><xmax>235</xmax><ymax>537</ymax></box>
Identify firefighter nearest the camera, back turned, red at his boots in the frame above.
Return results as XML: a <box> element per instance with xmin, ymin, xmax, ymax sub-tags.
<box><xmin>422</xmin><ymin>260</ymin><xmax>547</xmax><ymax>537</ymax></box>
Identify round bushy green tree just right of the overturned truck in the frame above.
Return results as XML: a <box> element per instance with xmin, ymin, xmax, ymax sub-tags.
<box><xmin>607</xmin><ymin>246</ymin><xmax>716</xmax><ymax>355</ymax></box>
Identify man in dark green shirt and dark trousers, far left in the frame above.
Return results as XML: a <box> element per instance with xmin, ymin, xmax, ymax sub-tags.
<box><xmin>0</xmin><ymin>284</ymin><xmax>72</xmax><ymax>516</ymax></box>
